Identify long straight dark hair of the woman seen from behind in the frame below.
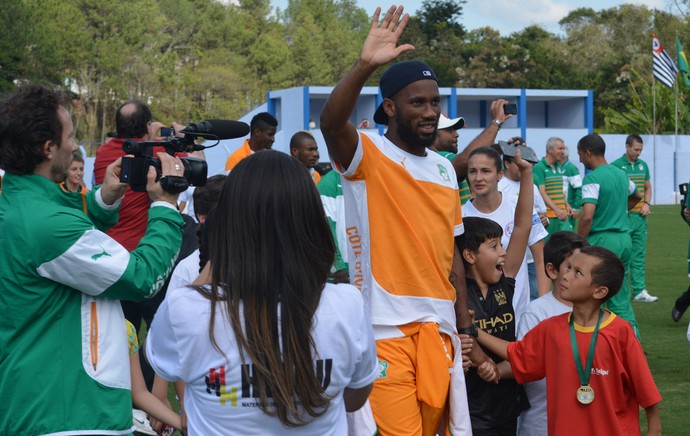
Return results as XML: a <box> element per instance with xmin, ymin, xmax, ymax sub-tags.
<box><xmin>202</xmin><ymin>150</ymin><xmax>335</xmax><ymax>427</ymax></box>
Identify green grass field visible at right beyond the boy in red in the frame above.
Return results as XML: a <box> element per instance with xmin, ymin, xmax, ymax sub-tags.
<box><xmin>159</xmin><ymin>206</ymin><xmax>690</xmax><ymax>435</ymax></box>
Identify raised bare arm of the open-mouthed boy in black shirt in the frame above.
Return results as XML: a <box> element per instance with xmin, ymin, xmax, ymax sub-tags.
<box><xmin>503</xmin><ymin>149</ymin><xmax>534</xmax><ymax>277</ymax></box>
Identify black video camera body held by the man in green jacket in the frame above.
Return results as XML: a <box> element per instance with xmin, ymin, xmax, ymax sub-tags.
<box><xmin>120</xmin><ymin>138</ymin><xmax>208</xmax><ymax>193</ymax></box>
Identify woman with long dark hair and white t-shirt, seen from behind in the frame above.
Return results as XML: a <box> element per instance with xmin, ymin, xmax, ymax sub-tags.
<box><xmin>146</xmin><ymin>151</ymin><xmax>378</xmax><ymax>435</ymax></box>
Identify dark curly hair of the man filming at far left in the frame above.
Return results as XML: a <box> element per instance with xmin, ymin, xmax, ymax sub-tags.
<box><xmin>0</xmin><ymin>83</ymin><xmax>68</xmax><ymax>174</ymax></box>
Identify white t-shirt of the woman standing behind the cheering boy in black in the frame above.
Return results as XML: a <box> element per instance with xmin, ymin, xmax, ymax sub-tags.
<box><xmin>462</xmin><ymin>195</ymin><xmax>548</xmax><ymax>322</ymax></box>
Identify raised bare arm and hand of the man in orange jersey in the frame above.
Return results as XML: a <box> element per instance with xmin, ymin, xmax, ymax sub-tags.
<box><xmin>321</xmin><ymin>6</ymin><xmax>414</xmax><ymax>168</ymax></box>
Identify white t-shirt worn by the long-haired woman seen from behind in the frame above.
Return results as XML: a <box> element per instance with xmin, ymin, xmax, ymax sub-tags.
<box><xmin>146</xmin><ymin>284</ymin><xmax>379</xmax><ymax>435</ymax></box>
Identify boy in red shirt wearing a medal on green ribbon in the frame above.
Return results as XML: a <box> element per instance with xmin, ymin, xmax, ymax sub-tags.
<box><xmin>478</xmin><ymin>246</ymin><xmax>661</xmax><ymax>435</ymax></box>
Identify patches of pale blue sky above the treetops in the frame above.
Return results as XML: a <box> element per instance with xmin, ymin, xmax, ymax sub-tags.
<box><xmin>271</xmin><ymin>0</ymin><xmax>673</xmax><ymax>35</ymax></box>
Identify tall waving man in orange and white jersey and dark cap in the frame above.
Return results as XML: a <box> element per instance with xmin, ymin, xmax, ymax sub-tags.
<box><xmin>321</xmin><ymin>6</ymin><xmax>484</xmax><ymax>435</ymax></box>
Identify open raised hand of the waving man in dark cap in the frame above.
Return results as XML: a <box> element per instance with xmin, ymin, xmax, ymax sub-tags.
<box><xmin>359</xmin><ymin>6</ymin><xmax>414</xmax><ymax>68</ymax></box>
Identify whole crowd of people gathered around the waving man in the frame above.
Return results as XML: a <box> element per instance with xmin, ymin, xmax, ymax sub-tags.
<box><xmin>0</xmin><ymin>7</ymin><xmax>690</xmax><ymax>435</ymax></box>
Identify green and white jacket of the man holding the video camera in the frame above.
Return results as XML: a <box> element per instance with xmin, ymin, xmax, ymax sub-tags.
<box><xmin>0</xmin><ymin>174</ymin><xmax>183</xmax><ymax>435</ymax></box>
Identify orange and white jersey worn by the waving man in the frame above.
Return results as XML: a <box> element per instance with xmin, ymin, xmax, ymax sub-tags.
<box><xmin>334</xmin><ymin>132</ymin><xmax>463</xmax><ymax>339</ymax></box>
